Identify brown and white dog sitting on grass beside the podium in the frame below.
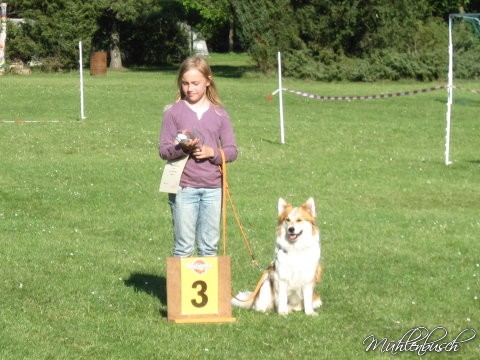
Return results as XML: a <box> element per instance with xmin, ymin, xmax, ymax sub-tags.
<box><xmin>232</xmin><ymin>198</ymin><xmax>322</xmax><ymax>316</ymax></box>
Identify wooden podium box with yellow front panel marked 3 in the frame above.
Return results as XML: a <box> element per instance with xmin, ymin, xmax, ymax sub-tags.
<box><xmin>167</xmin><ymin>256</ymin><xmax>236</xmax><ymax>323</ymax></box>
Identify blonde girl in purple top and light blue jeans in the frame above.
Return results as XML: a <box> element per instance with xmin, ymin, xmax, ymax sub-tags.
<box><xmin>159</xmin><ymin>55</ymin><xmax>237</xmax><ymax>257</ymax></box>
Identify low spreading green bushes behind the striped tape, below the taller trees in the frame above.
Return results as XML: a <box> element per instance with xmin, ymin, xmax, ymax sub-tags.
<box><xmin>282</xmin><ymin>27</ymin><xmax>480</xmax><ymax>82</ymax></box>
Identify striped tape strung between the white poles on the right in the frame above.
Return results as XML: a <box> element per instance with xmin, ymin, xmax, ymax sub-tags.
<box><xmin>265</xmin><ymin>85</ymin><xmax>480</xmax><ymax>101</ymax></box>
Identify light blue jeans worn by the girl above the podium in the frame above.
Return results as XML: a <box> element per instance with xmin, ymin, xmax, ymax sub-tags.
<box><xmin>168</xmin><ymin>187</ymin><xmax>222</xmax><ymax>257</ymax></box>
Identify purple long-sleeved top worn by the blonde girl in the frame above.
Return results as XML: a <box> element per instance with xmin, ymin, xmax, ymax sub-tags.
<box><xmin>159</xmin><ymin>100</ymin><xmax>238</xmax><ymax>188</ymax></box>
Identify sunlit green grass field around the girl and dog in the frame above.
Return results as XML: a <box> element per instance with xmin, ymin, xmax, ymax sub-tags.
<box><xmin>0</xmin><ymin>55</ymin><xmax>480</xmax><ymax>360</ymax></box>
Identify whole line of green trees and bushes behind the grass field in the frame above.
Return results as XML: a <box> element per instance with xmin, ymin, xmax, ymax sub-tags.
<box><xmin>6</xmin><ymin>0</ymin><xmax>480</xmax><ymax>81</ymax></box>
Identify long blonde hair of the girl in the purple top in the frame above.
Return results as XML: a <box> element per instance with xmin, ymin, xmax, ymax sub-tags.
<box><xmin>175</xmin><ymin>55</ymin><xmax>222</xmax><ymax>106</ymax></box>
